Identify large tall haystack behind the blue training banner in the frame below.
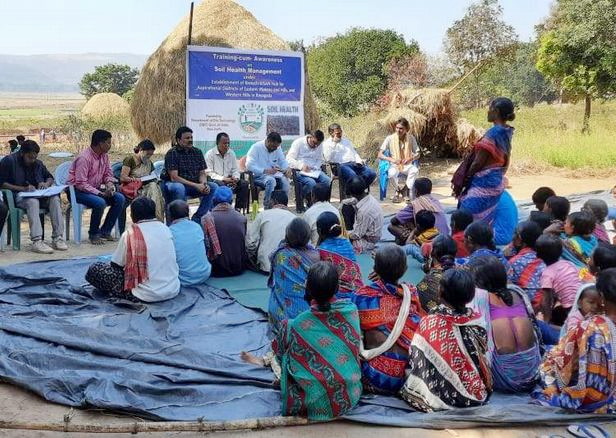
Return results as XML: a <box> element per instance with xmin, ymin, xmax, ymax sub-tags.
<box><xmin>131</xmin><ymin>0</ymin><xmax>319</xmax><ymax>144</ymax></box>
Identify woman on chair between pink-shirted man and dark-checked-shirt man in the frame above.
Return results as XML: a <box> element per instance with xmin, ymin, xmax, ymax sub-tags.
<box><xmin>120</xmin><ymin>139</ymin><xmax>165</xmax><ymax>221</ymax></box>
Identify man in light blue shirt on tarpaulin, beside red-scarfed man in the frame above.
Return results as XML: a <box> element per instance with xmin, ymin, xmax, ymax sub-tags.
<box><xmin>168</xmin><ymin>199</ymin><xmax>212</xmax><ymax>286</ymax></box>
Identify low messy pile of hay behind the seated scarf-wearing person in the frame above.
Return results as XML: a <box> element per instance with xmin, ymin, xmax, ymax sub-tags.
<box><xmin>363</xmin><ymin>88</ymin><xmax>482</xmax><ymax>162</ymax></box>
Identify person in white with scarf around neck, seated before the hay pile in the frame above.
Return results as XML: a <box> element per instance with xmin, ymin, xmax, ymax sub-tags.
<box><xmin>378</xmin><ymin>117</ymin><xmax>419</xmax><ymax>202</ymax></box>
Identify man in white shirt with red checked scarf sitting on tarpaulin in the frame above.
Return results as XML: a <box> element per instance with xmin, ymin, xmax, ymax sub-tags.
<box><xmin>86</xmin><ymin>197</ymin><xmax>180</xmax><ymax>302</ymax></box>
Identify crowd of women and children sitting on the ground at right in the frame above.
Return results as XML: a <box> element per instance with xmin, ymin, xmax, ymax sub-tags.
<box><xmin>242</xmin><ymin>182</ymin><xmax>616</xmax><ymax>419</ymax></box>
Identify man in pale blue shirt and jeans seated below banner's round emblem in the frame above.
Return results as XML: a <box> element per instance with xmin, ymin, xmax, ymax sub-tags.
<box><xmin>246</xmin><ymin>132</ymin><xmax>291</xmax><ymax>209</ymax></box>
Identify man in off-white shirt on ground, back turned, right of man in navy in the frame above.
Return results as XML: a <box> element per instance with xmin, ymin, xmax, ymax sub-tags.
<box><xmin>246</xmin><ymin>190</ymin><xmax>296</xmax><ymax>272</ymax></box>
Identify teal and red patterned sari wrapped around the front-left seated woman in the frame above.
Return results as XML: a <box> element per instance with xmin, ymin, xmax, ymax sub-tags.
<box><xmin>273</xmin><ymin>300</ymin><xmax>362</xmax><ymax>420</ymax></box>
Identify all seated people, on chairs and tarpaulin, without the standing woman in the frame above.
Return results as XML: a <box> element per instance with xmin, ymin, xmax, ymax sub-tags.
<box><xmin>0</xmin><ymin>122</ymin><xmax>616</xmax><ymax>420</ymax></box>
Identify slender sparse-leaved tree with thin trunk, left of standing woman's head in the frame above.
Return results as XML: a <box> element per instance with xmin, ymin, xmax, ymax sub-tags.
<box><xmin>444</xmin><ymin>0</ymin><xmax>518</xmax><ymax>108</ymax></box>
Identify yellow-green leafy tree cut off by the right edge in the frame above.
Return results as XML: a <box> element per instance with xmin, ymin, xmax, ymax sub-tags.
<box><xmin>537</xmin><ymin>0</ymin><xmax>616</xmax><ymax>133</ymax></box>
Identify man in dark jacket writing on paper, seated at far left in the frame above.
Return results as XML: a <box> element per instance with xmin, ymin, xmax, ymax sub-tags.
<box><xmin>0</xmin><ymin>140</ymin><xmax>68</xmax><ymax>254</ymax></box>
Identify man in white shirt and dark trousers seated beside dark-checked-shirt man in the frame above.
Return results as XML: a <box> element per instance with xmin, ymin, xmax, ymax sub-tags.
<box><xmin>205</xmin><ymin>132</ymin><xmax>248</xmax><ymax>210</ymax></box>
